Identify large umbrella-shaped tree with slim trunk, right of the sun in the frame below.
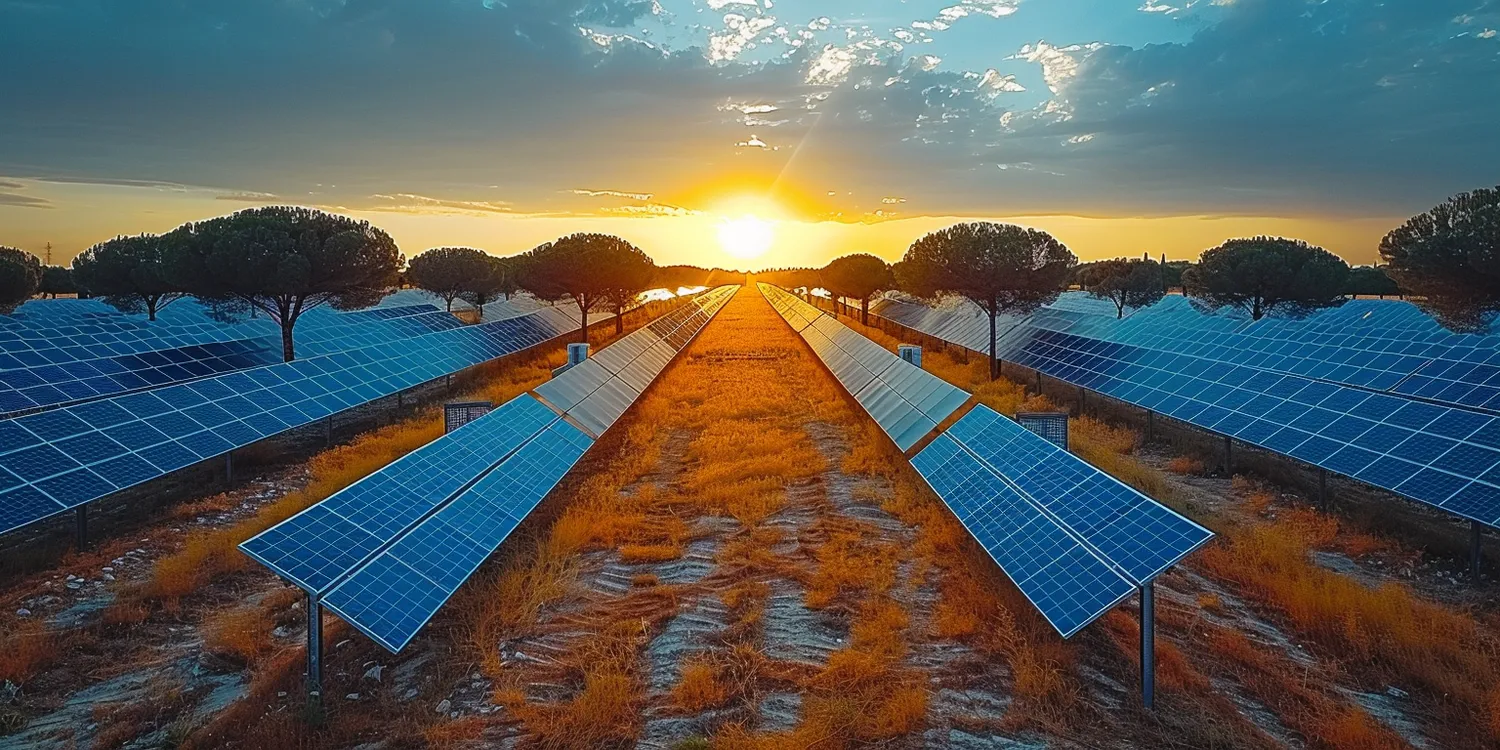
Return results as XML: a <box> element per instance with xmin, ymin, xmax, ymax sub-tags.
<box><xmin>896</xmin><ymin>222</ymin><xmax>1079</xmax><ymax>380</ymax></box>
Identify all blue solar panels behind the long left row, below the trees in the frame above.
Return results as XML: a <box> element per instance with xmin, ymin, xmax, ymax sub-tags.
<box><xmin>0</xmin><ymin>300</ymin><xmax>462</xmax><ymax>414</ymax></box>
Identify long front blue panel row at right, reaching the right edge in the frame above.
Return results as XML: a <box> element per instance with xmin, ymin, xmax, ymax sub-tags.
<box><xmin>881</xmin><ymin>295</ymin><xmax>1500</xmax><ymax>525</ymax></box>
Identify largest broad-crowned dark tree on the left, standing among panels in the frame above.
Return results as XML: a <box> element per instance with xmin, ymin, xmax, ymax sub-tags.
<box><xmin>168</xmin><ymin>206</ymin><xmax>402</xmax><ymax>362</ymax></box>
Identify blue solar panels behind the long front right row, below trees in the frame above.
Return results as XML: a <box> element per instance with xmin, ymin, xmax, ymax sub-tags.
<box><xmin>872</xmin><ymin>293</ymin><xmax>1500</xmax><ymax>413</ymax></box>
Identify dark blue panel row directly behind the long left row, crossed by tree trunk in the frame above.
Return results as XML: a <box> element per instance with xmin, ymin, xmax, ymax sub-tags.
<box><xmin>0</xmin><ymin>306</ymin><xmax>462</xmax><ymax>414</ymax></box>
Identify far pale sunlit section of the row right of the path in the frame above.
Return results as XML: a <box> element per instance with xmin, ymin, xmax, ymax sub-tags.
<box><xmin>762</xmin><ymin>285</ymin><xmax>969</xmax><ymax>450</ymax></box>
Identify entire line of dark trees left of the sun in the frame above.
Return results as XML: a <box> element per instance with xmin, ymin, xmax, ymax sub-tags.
<box><xmin>0</xmin><ymin>206</ymin><xmax>744</xmax><ymax>362</ymax></box>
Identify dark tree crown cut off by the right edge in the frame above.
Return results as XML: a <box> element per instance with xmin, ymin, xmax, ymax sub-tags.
<box><xmin>1380</xmin><ymin>186</ymin><xmax>1500</xmax><ymax>332</ymax></box>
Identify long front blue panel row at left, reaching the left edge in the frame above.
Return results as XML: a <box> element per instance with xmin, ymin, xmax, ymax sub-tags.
<box><xmin>0</xmin><ymin>309</ymin><xmax>578</xmax><ymax>533</ymax></box>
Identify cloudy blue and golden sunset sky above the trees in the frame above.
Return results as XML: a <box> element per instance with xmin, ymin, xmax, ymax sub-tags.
<box><xmin>0</xmin><ymin>0</ymin><xmax>1500</xmax><ymax>269</ymax></box>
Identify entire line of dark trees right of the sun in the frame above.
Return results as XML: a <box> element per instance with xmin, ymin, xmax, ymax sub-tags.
<box><xmin>758</xmin><ymin>188</ymin><xmax>1500</xmax><ymax>378</ymax></box>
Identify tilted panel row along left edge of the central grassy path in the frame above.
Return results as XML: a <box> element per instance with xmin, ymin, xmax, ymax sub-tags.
<box><xmin>240</xmin><ymin>287</ymin><xmax>737</xmax><ymax>651</ymax></box>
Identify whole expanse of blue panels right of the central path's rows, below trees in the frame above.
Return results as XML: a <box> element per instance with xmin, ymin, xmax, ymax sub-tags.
<box><xmin>873</xmin><ymin>296</ymin><xmax>1500</xmax><ymax>525</ymax></box>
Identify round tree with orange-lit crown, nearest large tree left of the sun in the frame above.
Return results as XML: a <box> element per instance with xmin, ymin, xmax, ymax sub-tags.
<box><xmin>521</xmin><ymin>233</ymin><xmax>650</xmax><ymax>344</ymax></box>
